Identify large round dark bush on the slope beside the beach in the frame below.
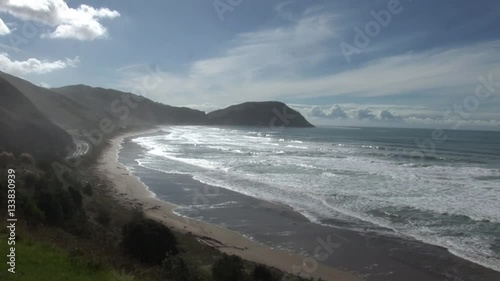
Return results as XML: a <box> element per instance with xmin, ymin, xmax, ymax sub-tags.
<box><xmin>122</xmin><ymin>219</ymin><xmax>179</xmax><ymax>264</ymax></box>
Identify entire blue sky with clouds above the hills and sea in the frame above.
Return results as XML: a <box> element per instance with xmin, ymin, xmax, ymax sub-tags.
<box><xmin>0</xmin><ymin>0</ymin><xmax>500</xmax><ymax>130</ymax></box>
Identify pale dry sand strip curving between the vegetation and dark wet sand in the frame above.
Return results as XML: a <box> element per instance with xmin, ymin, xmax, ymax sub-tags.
<box><xmin>96</xmin><ymin>128</ymin><xmax>361</xmax><ymax>281</ymax></box>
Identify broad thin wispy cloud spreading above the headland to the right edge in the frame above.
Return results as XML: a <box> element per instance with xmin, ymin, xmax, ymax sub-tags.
<box><xmin>114</xmin><ymin>9</ymin><xmax>500</xmax><ymax>109</ymax></box>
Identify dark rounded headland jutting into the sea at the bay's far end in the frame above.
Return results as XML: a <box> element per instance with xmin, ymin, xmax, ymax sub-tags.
<box><xmin>207</xmin><ymin>101</ymin><xmax>314</xmax><ymax>128</ymax></box>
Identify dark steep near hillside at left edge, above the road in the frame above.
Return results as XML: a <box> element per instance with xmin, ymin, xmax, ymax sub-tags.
<box><xmin>0</xmin><ymin>77</ymin><xmax>73</xmax><ymax>160</ymax></box>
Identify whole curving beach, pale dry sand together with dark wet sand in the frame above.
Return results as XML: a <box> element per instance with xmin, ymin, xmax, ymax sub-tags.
<box><xmin>96</xmin><ymin>128</ymin><xmax>500</xmax><ymax>281</ymax></box>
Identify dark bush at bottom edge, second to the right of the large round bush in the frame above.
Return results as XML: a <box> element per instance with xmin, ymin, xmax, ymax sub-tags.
<box><xmin>212</xmin><ymin>255</ymin><xmax>245</xmax><ymax>281</ymax></box>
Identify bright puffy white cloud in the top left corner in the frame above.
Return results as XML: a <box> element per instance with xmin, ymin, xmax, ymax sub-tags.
<box><xmin>0</xmin><ymin>0</ymin><xmax>120</xmax><ymax>41</ymax></box>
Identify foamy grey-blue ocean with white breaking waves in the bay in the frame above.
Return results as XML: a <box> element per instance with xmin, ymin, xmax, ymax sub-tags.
<box><xmin>125</xmin><ymin>126</ymin><xmax>500</xmax><ymax>271</ymax></box>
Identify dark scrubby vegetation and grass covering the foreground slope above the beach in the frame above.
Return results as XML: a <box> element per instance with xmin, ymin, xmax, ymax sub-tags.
<box><xmin>0</xmin><ymin>152</ymin><xmax>320</xmax><ymax>281</ymax></box>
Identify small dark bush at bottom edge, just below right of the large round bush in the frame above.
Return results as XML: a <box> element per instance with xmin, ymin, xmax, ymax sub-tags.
<box><xmin>162</xmin><ymin>256</ymin><xmax>201</xmax><ymax>281</ymax></box>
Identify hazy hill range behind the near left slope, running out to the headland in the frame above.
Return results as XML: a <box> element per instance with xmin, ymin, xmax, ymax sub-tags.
<box><xmin>0</xmin><ymin>72</ymin><xmax>313</xmax><ymax>142</ymax></box>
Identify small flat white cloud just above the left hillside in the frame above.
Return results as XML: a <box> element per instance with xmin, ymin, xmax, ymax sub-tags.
<box><xmin>0</xmin><ymin>53</ymin><xmax>80</xmax><ymax>75</ymax></box>
